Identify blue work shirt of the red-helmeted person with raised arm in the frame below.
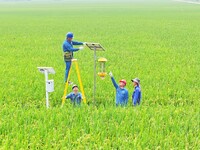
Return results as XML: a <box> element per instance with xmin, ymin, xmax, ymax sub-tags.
<box><xmin>111</xmin><ymin>77</ymin><xmax>128</xmax><ymax>106</ymax></box>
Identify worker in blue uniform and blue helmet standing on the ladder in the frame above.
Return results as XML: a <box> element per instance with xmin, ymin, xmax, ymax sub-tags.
<box><xmin>63</xmin><ymin>32</ymin><xmax>85</xmax><ymax>84</ymax></box>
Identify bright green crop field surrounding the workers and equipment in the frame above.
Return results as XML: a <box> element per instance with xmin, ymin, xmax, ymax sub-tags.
<box><xmin>0</xmin><ymin>1</ymin><xmax>200</xmax><ymax>150</ymax></box>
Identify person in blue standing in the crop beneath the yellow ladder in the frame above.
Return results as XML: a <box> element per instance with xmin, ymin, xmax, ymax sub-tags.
<box><xmin>66</xmin><ymin>85</ymin><xmax>82</xmax><ymax>105</ymax></box>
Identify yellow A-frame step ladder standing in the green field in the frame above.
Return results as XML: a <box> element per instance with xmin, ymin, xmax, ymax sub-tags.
<box><xmin>62</xmin><ymin>59</ymin><xmax>86</xmax><ymax>106</ymax></box>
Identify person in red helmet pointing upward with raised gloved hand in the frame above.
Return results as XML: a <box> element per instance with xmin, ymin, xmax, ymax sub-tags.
<box><xmin>109</xmin><ymin>72</ymin><xmax>128</xmax><ymax>106</ymax></box>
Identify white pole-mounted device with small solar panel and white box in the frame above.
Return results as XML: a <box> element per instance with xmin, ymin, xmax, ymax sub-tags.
<box><xmin>37</xmin><ymin>67</ymin><xmax>55</xmax><ymax>108</ymax></box>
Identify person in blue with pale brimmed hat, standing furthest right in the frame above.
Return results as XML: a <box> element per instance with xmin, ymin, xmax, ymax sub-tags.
<box><xmin>131</xmin><ymin>78</ymin><xmax>142</xmax><ymax>106</ymax></box>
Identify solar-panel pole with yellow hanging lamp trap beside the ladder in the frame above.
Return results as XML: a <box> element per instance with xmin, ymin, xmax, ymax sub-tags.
<box><xmin>86</xmin><ymin>43</ymin><xmax>107</xmax><ymax>103</ymax></box>
